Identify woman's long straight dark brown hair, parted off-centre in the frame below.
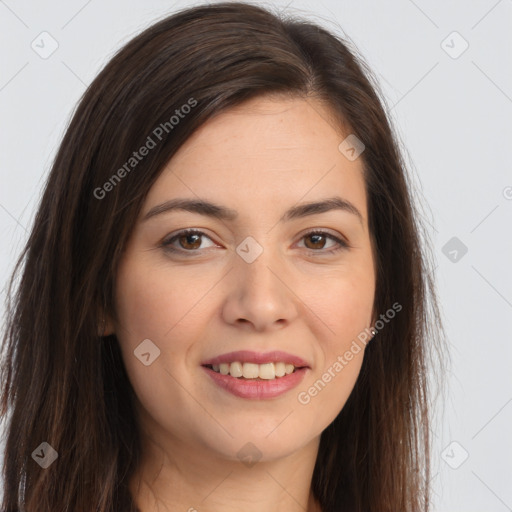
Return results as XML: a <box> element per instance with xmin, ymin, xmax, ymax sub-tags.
<box><xmin>0</xmin><ymin>2</ymin><xmax>441</xmax><ymax>512</ymax></box>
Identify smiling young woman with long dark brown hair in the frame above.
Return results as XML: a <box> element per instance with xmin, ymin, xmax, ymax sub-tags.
<box><xmin>2</xmin><ymin>2</ymin><xmax>440</xmax><ymax>512</ymax></box>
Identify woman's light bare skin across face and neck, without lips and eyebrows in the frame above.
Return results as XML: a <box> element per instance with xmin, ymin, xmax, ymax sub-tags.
<box><xmin>107</xmin><ymin>96</ymin><xmax>376</xmax><ymax>512</ymax></box>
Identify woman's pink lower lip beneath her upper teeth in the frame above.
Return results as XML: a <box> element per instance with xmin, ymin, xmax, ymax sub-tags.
<box><xmin>202</xmin><ymin>366</ymin><xmax>308</xmax><ymax>400</ymax></box>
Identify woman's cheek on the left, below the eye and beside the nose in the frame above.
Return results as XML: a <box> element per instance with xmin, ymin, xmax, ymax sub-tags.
<box><xmin>115</xmin><ymin>254</ymin><xmax>214</xmax><ymax>400</ymax></box>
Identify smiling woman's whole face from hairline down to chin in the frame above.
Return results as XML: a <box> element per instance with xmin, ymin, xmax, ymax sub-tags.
<box><xmin>111</xmin><ymin>97</ymin><xmax>375</xmax><ymax>460</ymax></box>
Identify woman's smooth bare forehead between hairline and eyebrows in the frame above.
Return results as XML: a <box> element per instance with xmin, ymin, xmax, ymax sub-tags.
<box><xmin>146</xmin><ymin>97</ymin><xmax>366</xmax><ymax>222</ymax></box>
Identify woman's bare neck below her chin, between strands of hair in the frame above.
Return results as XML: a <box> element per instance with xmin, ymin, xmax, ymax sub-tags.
<box><xmin>130</xmin><ymin>422</ymin><xmax>321</xmax><ymax>512</ymax></box>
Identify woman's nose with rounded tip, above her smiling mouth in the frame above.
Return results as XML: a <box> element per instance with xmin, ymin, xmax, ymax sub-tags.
<box><xmin>222</xmin><ymin>250</ymin><xmax>300</xmax><ymax>332</ymax></box>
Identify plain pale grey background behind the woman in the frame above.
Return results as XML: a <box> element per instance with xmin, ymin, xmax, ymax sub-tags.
<box><xmin>0</xmin><ymin>0</ymin><xmax>512</xmax><ymax>512</ymax></box>
